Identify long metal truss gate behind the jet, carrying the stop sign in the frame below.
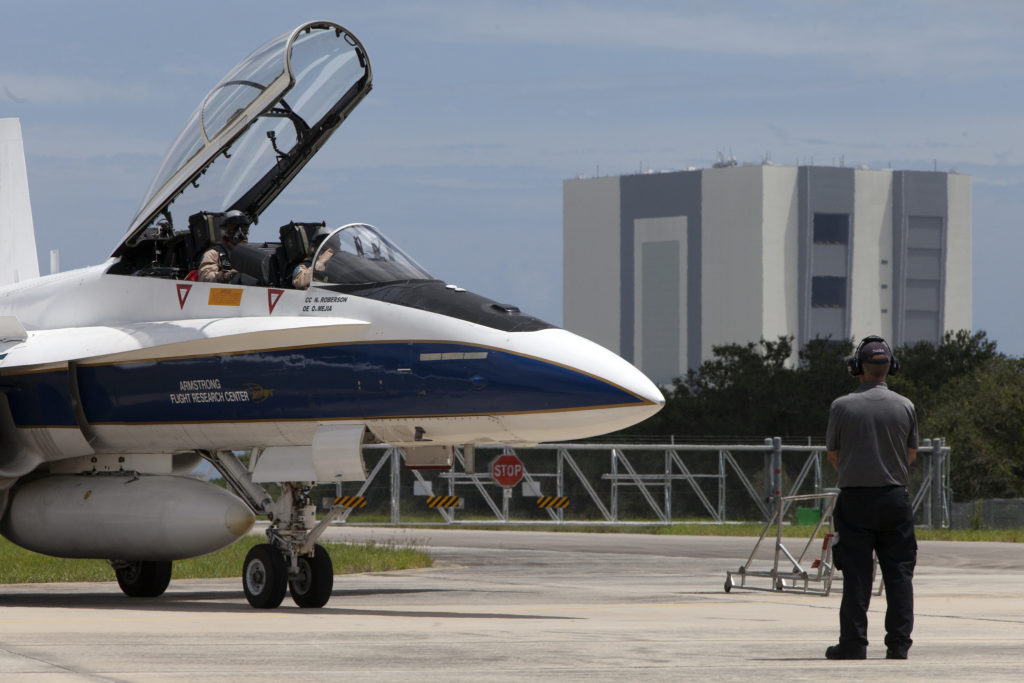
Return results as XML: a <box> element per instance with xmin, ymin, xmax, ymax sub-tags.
<box><xmin>329</xmin><ymin>437</ymin><xmax>951</xmax><ymax>528</ymax></box>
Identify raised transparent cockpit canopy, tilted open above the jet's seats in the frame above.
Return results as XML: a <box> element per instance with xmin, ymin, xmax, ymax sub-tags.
<box><xmin>114</xmin><ymin>22</ymin><xmax>373</xmax><ymax>256</ymax></box>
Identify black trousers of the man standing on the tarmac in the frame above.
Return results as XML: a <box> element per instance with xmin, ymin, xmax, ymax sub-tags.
<box><xmin>836</xmin><ymin>486</ymin><xmax>918</xmax><ymax>650</ymax></box>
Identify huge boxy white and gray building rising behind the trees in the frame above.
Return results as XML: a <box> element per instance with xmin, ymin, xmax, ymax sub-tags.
<box><xmin>562</xmin><ymin>165</ymin><xmax>971</xmax><ymax>383</ymax></box>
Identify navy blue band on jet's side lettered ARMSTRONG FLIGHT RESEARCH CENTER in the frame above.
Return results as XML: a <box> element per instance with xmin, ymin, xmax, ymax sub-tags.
<box><xmin>68</xmin><ymin>342</ymin><xmax>643</xmax><ymax>424</ymax></box>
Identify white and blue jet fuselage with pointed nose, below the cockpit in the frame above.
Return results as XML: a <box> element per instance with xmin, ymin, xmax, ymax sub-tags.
<box><xmin>0</xmin><ymin>266</ymin><xmax>660</xmax><ymax>459</ymax></box>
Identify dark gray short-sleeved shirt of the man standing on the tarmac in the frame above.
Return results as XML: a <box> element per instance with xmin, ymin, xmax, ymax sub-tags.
<box><xmin>825</xmin><ymin>382</ymin><xmax>918</xmax><ymax>488</ymax></box>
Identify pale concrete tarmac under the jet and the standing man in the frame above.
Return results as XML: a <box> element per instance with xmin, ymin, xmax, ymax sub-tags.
<box><xmin>0</xmin><ymin>526</ymin><xmax>1024</xmax><ymax>682</ymax></box>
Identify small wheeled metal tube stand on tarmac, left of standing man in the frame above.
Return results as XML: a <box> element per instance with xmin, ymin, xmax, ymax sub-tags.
<box><xmin>725</xmin><ymin>492</ymin><xmax>839</xmax><ymax>596</ymax></box>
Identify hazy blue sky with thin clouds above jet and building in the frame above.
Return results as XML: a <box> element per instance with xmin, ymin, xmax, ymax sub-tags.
<box><xmin>0</xmin><ymin>0</ymin><xmax>1024</xmax><ymax>355</ymax></box>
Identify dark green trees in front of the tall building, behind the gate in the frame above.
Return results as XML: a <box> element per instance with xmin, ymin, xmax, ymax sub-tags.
<box><xmin>610</xmin><ymin>330</ymin><xmax>1024</xmax><ymax>500</ymax></box>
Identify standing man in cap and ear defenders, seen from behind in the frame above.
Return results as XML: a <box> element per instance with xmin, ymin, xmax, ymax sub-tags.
<box><xmin>825</xmin><ymin>337</ymin><xmax>918</xmax><ymax>659</ymax></box>
